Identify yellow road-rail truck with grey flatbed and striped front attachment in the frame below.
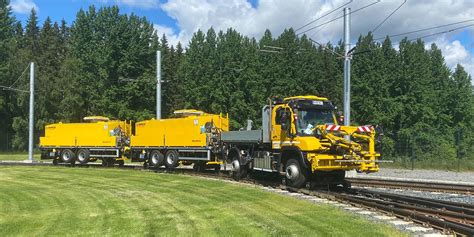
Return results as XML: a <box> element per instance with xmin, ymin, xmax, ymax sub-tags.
<box><xmin>220</xmin><ymin>96</ymin><xmax>380</xmax><ymax>187</ymax></box>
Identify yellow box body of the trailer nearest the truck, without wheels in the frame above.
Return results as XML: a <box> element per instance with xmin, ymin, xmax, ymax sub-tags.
<box><xmin>130</xmin><ymin>113</ymin><xmax>229</xmax><ymax>148</ymax></box>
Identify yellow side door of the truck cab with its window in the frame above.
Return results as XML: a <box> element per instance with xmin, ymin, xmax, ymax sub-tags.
<box><xmin>272</xmin><ymin>105</ymin><xmax>291</xmax><ymax>149</ymax></box>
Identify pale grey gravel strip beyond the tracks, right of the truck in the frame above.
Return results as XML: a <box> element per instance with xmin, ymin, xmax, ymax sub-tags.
<box><xmin>354</xmin><ymin>168</ymin><xmax>474</xmax><ymax>185</ymax></box>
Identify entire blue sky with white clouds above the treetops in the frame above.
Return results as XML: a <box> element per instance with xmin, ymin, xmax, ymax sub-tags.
<box><xmin>10</xmin><ymin>0</ymin><xmax>474</xmax><ymax>77</ymax></box>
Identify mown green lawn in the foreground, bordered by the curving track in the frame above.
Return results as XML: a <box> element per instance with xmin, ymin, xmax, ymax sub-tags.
<box><xmin>0</xmin><ymin>166</ymin><xmax>404</xmax><ymax>236</ymax></box>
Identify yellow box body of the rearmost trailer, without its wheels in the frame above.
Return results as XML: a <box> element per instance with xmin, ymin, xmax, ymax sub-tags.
<box><xmin>40</xmin><ymin>121</ymin><xmax>131</xmax><ymax>147</ymax></box>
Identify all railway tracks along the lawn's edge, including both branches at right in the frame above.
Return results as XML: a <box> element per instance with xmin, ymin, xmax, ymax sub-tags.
<box><xmin>0</xmin><ymin>162</ymin><xmax>474</xmax><ymax>236</ymax></box>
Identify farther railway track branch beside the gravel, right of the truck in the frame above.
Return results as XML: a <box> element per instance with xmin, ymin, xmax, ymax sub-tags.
<box><xmin>347</xmin><ymin>178</ymin><xmax>474</xmax><ymax>195</ymax></box>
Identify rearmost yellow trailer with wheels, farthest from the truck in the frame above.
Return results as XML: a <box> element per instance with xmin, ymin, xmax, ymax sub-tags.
<box><xmin>40</xmin><ymin>116</ymin><xmax>132</xmax><ymax>166</ymax></box>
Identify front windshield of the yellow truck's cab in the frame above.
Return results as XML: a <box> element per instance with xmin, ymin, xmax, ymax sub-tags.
<box><xmin>296</xmin><ymin>109</ymin><xmax>334</xmax><ymax>135</ymax></box>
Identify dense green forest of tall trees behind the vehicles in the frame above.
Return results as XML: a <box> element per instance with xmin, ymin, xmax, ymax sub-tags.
<box><xmin>0</xmin><ymin>0</ymin><xmax>474</xmax><ymax>165</ymax></box>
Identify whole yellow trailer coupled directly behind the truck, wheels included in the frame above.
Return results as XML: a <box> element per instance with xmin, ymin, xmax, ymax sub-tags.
<box><xmin>130</xmin><ymin>109</ymin><xmax>229</xmax><ymax>170</ymax></box>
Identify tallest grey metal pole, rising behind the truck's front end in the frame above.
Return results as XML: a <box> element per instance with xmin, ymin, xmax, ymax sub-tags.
<box><xmin>344</xmin><ymin>7</ymin><xmax>351</xmax><ymax>126</ymax></box>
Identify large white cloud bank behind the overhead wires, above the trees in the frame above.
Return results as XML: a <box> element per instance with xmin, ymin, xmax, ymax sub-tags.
<box><xmin>161</xmin><ymin>0</ymin><xmax>474</xmax><ymax>79</ymax></box>
